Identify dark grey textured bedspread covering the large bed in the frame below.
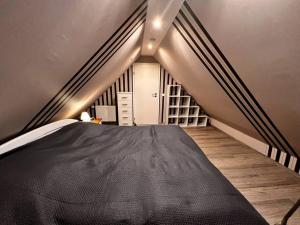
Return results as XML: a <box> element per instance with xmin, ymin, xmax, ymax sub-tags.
<box><xmin>0</xmin><ymin>122</ymin><xmax>267</xmax><ymax>225</ymax></box>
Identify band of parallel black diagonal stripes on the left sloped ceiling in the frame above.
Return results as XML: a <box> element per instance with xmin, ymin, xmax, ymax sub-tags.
<box><xmin>19</xmin><ymin>0</ymin><xmax>147</xmax><ymax>134</ymax></box>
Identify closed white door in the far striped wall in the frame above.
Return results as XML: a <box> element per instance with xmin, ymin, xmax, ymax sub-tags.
<box><xmin>133</xmin><ymin>63</ymin><xmax>160</xmax><ymax>125</ymax></box>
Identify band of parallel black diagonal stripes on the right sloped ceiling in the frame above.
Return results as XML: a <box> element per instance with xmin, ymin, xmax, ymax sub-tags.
<box><xmin>173</xmin><ymin>2</ymin><xmax>299</xmax><ymax>158</ymax></box>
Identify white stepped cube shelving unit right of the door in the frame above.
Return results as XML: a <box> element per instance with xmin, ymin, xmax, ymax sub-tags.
<box><xmin>164</xmin><ymin>85</ymin><xmax>208</xmax><ymax>127</ymax></box>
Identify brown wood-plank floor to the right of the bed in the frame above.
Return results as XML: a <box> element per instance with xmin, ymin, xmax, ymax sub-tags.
<box><xmin>184</xmin><ymin>127</ymin><xmax>300</xmax><ymax>225</ymax></box>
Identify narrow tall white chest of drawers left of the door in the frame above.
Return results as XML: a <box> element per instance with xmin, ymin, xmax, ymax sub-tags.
<box><xmin>117</xmin><ymin>92</ymin><xmax>133</xmax><ymax>126</ymax></box>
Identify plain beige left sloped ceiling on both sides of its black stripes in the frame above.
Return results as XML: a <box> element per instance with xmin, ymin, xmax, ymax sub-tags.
<box><xmin>0</xmin><ymin>0</ymin><xmax>142</xmax><ymax>140</ymax></box>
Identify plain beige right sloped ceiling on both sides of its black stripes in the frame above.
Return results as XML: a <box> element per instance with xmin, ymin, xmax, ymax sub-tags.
<box><xmin>155</xmin><ymin>0</ymin><xmax>300</xmax><ymax>156</ymax></box>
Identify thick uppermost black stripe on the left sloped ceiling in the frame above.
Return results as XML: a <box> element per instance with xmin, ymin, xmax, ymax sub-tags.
<box><xmin>19</xmin><ymin>0</ymin><xmax>147</xmax><ymax>134</ymax></box>
